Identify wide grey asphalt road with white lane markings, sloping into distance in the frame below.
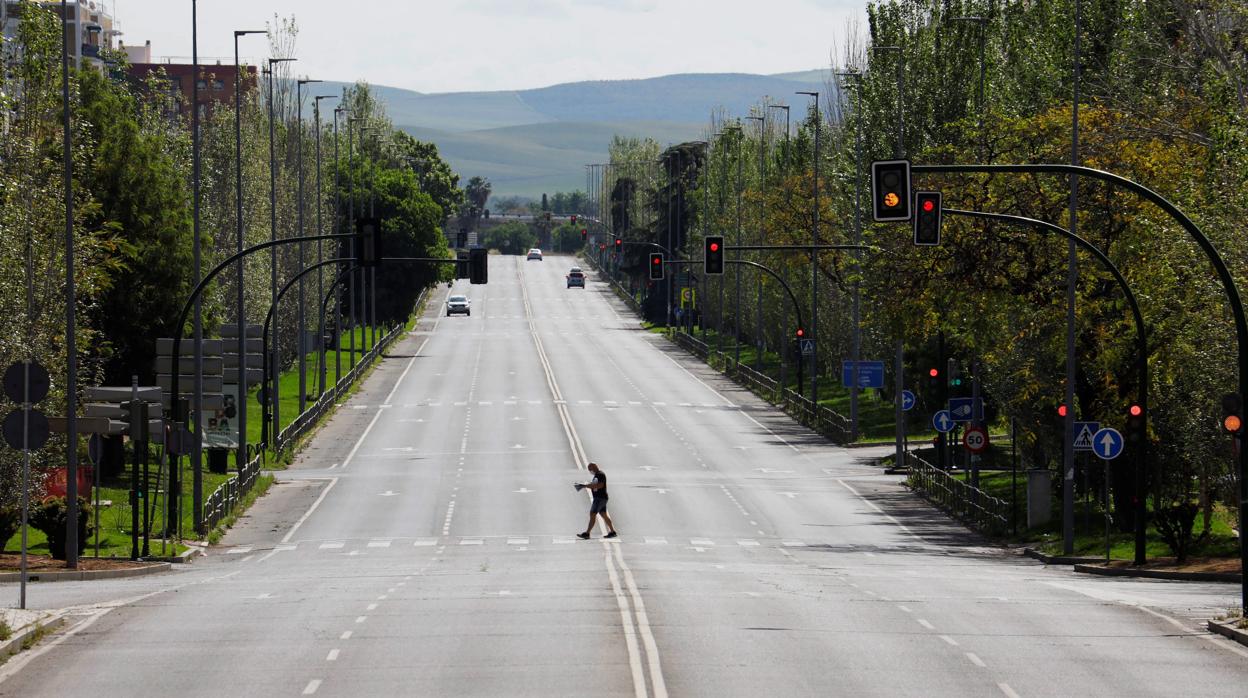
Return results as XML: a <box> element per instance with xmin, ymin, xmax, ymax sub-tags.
<box><xmin>0</xmin><ymin>255</ymin><xmax>1248</xmax><ymax>697</ymax></box>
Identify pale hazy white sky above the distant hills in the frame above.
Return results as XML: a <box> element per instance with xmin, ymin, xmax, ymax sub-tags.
<box><xmin>96</xmin><ymin>0</ymin><xmax>866</xmax><ymax>92</ymax></box>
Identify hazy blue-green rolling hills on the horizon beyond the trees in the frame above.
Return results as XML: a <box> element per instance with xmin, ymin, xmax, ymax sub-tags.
<box><xmin>322</xmin><ymin>70</ymin><xmax>827</xmax><ymax>197</ymax></box>
